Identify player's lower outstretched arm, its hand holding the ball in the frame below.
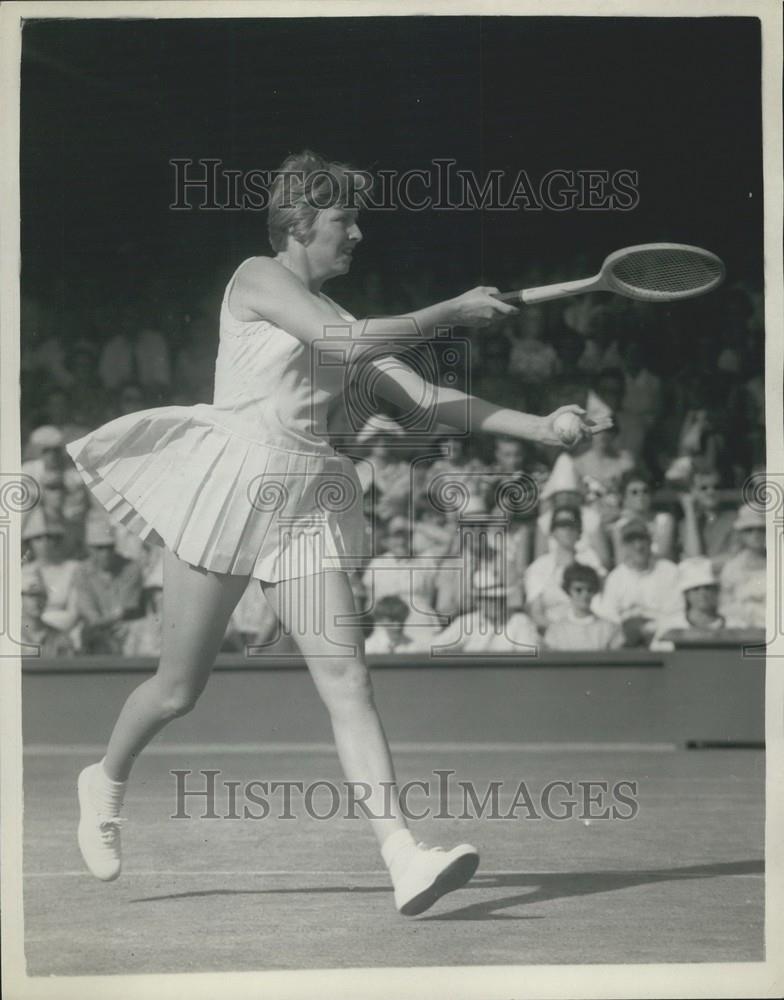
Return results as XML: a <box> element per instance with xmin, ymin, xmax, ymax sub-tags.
<box><xmin>370</xmin><ymin>357</ymin><xmax>612</xmax><ymax>447</ymax></box>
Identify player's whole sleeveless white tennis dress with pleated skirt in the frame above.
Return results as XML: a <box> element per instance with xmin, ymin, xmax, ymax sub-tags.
<box><xmin>67</xmin><ymin>261</ymin><xmax>365</xmax><ymax>582</ymax></box>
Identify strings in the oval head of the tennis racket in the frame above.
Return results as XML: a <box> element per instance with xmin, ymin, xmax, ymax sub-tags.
<box><xmin>612</xmin><ymin>249</ymin><xmax>723</xmax><ymax>297</ymax></box>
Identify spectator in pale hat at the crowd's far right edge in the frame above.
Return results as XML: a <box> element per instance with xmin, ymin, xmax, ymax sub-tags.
<box><xmin>719</xmin><ymin>504</ymin><xmax>767</xmax><ymax>628</ymax></box>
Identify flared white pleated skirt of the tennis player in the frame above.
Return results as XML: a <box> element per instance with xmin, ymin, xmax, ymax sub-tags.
<box><xmin>67</xmin><ymin>404</ymin><xmax>365</xmax><ymax>583</ymax></box>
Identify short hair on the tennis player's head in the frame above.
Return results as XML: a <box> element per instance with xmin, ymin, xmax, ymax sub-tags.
<box><xmin>267</xmin><ymin>149</ymin><xmax>370</xmax><ymax>251</ymax></box>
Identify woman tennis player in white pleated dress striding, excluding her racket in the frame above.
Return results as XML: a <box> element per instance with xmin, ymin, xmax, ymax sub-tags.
<box><xmin>68</xmin><ymin>152</ymin><xmax>598</xmax><ymax>915</ymax></box>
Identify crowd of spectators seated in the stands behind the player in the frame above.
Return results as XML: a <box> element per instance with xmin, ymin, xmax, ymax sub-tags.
<box><xmin>21</xmin><ymin>262</ymin><xmax>765</xmax><ymax>656</ymax></box>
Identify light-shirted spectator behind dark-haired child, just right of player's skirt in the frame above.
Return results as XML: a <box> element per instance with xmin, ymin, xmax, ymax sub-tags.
<box><xmin>364</xmin><ymin>517</ymin><xmax>438</xmax><ymax>638</ymax></box>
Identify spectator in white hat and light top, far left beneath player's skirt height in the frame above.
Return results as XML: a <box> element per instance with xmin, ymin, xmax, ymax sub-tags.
<box><xmin>22</xmin><ymin>505</ymin><xmax>80</xmax><ymax>632</ymax></box>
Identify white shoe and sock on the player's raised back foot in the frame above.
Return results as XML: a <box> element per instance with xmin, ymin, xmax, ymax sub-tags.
<box><xmin>77</xmin><ymin>763</ymin><xmax>125</xmax><ymax>882</ymax></box>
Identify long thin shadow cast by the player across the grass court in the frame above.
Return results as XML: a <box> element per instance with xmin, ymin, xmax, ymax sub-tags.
<box><xmin>128</xmin><ymin>860</ymin><xmax>765</xmax><ymax>920</ymax></box>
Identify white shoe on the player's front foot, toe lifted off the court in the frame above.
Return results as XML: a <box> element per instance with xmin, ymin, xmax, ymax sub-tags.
<box><xmin>390</xmin><ymin>844</ymin><xmax>479</xmax><ymax>917</ymax></box>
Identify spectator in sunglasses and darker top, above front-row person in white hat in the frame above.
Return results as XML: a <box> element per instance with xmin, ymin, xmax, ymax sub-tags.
<box><xmin>679</xmin><ymin>464</ymin><xmax>739</xmax><ymax>571</ymax></box>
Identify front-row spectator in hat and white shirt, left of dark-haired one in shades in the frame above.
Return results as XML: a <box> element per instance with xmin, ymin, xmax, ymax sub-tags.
<box><xmin>431</xmin><ymin>574</ymin><xmax>539</xmax><ymax>656</ymax></box>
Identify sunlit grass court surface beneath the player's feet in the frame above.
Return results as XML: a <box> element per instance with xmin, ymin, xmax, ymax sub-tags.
<box><xmin>24</xmin><ymin>743</ymin><xmax>764</xmax><ymax>976</ymax></box>
